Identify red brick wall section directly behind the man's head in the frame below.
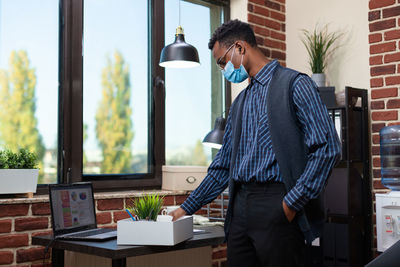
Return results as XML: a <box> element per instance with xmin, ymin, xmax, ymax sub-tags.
<box><xmin>247</xmin><ymin>0</ymin><xmax>286</xmax><ymax>66</ymax></box>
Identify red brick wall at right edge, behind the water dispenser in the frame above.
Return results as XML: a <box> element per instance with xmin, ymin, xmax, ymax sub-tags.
<box><xmin>368</xmin><ymin>0</ymin><xmax>400</xmax><ymax>256</ymax></box>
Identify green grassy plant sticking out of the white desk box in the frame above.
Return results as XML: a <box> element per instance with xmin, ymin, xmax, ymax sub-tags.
<box><xmin>128</xmin><ymin>194</ymin><xmax>164</xmax><ymax>221</ymax></box>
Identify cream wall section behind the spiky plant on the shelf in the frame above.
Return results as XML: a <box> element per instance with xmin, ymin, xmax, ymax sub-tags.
<box><xmin>286</xmin><ymin>0</ymin><xmax>370</xmax><ymax>92</ymax></box>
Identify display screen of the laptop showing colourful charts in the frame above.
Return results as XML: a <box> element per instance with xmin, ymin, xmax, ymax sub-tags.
<box><xmin>52</xmin><ymin>188</ymin><xmax>95</xmax><ymax>230</ymax></box>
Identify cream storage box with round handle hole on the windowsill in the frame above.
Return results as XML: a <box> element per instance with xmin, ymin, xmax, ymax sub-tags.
<box><xmin>162</xmin><ymin>166</ymin><xmax>208</xmax><ymax>191</ymax></box>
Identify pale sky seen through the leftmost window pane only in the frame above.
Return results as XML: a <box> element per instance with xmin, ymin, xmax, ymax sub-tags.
<box><xmin>0</xmin><ymin>0</ymin><xmax>58</xmax><ymax>147</ymax></box>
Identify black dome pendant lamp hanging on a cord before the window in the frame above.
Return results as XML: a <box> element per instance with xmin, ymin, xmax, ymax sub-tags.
<box><xmin>159</xmin><ymin>0</ymin><xmax>200</xmax><ymax>68</ymax></box>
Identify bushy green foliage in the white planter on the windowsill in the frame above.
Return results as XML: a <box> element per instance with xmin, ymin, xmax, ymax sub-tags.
<box><xmin>0</xmin><ymin>148</ymin><xmax>38</xmax><ymax>169</ymax></box>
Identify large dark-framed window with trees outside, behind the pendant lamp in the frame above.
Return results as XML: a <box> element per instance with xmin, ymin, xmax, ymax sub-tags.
<box><xmin>0</xmin><ymin>0</ymin><xmax>230</xmax><ymax>192</ymax></box>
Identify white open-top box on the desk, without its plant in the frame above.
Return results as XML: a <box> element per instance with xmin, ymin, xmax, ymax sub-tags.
<box><xmin>117</xmin><ymin>216</ymin><xmax>193</xmax><ymax>246</ymax></box>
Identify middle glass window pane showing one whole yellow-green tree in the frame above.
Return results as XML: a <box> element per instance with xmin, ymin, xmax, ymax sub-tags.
<box><xmin>83</xmin><ymin>0</ymin><xmax>149</xmax><ymax>174</ymax></box>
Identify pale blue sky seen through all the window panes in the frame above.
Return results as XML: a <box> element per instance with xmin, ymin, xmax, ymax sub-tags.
<box><xmin>0</xmin><ymin>0</ymin><xmax>219</xmax><ymax>161</ymax></box>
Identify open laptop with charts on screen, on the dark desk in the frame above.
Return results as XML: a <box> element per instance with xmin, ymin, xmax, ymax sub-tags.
<box><xmin>49</xmin><ymin>183</ymin><xmax>117</xmax><ymax>241</ymax></box>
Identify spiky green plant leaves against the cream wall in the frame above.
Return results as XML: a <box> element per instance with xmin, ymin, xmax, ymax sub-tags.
<box><xmin>301</xmin><ymin>25</ymin><xmax>343</xmax><ymax>73</ymax></box>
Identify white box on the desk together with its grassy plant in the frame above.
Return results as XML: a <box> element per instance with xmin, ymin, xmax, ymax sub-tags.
<box><xmin>117</xmin><ymin>194</ymin><xmax>193</xmax><ymax>246</ymax></box>
